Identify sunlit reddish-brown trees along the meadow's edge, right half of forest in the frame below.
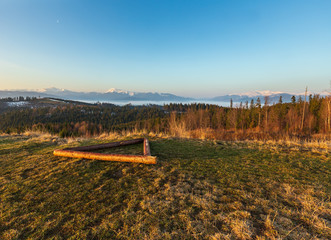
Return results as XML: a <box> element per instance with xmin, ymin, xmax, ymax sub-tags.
<box><xmin>168</xmin><ymin>95</ymin><xmax>331</xmax><ymax>139</ymax></box>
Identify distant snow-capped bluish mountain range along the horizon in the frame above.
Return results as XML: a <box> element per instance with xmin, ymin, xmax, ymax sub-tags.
<box><xmin>0</xmin><ymin>88</ymin><xmax>329</xmax><ymax>103</ymax></box>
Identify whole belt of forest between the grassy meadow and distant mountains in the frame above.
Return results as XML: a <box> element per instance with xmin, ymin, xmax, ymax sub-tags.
<box><xmin>0</xmin><ymin>95</ymin><xmax>331</xmax><ymax>140</ymax></box>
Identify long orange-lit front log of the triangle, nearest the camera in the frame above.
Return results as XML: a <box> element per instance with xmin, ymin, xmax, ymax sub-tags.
<box><xmin>54</xmin><ymin>150</ymin><xmax>156</xmax><ymax>164</ymax></box>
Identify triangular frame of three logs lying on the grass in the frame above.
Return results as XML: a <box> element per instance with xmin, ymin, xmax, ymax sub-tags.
<box><xmin>53</xmin><ymin>138</ymin><xmax>156</xmax><ymax>164</ymax></box>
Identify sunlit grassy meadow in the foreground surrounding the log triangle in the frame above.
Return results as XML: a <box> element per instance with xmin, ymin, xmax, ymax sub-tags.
<box><xmin>0</xmin><ymin>136</ymin><xmax>331</xmax><ymax>239</ymax></box>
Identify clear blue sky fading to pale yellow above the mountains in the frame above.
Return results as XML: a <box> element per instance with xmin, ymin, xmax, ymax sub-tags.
<box><xmin>0</xmin><ymin>0</ymin><xmax>331</xmax><ymax>97</ymax></box>
